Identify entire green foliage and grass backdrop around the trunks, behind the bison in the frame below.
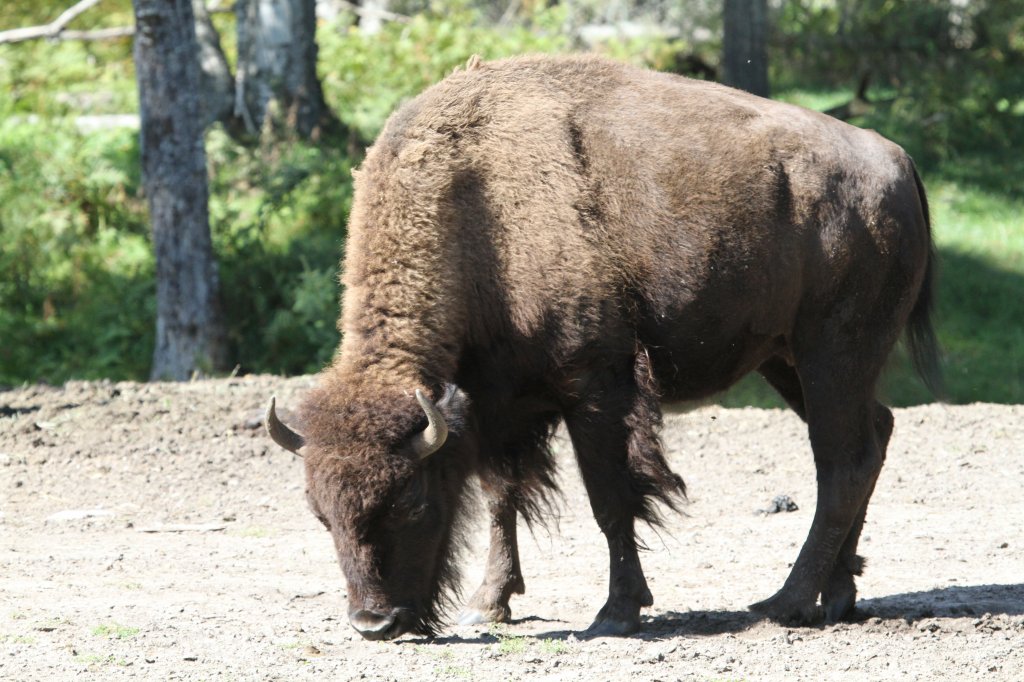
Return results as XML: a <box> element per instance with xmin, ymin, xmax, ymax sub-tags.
<box><xmin>0</xmin><ymin>0</ymin><xmax>1024</xmax><ymax>404</ymax></box>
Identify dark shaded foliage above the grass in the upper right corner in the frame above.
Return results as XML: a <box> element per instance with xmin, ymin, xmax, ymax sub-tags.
<box><xmin>774</xmin><ymin>0</ymin><xmax>1024</xmax><ymax>175</ymax></box>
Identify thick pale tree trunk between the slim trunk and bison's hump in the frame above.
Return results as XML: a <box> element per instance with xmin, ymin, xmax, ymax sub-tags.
<box><xmin>234</xmin><ymin>0</ymin><xmax>334</xmax><ymax>138</ymax></box>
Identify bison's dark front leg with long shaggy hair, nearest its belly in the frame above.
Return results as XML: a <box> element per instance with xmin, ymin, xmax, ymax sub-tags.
<box><xmin>565</xmin><ymin>353</ymin><xmax>684</xmax><ymax>636</ymax></box>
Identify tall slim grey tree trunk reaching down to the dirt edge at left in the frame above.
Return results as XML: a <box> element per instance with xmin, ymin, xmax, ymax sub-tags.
<box><xmin>132</xmin><ymin>0</ymin><xmax>225</xmax><ymax>380</ymax></box>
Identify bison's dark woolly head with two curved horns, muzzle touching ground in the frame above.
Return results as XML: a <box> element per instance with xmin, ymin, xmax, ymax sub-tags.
<box><xmin>266</xmin><ymin>386</ymin><xmax>473</xmax><ymax>639</ymax></box>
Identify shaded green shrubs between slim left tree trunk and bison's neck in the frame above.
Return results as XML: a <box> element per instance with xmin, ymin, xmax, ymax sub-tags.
<box><xmin>207</xmin><ymin>131</ymin><xmax>351</xmax><ymax>374</ymax></box>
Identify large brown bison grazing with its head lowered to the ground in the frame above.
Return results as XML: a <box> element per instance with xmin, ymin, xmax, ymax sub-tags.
<box><xmin>266</xmin><ymin>56</ymin><xmax>940</xmax><ymax>639</ymax></box>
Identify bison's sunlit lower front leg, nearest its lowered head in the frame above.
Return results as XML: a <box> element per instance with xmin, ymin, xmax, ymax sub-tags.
<box><xmin>459</xmin><ymin>485</ymin><xmax>526</xmax><ymax>625</ymax></box>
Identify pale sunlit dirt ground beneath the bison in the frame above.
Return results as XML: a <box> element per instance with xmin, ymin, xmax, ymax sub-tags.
<box><xmin>0</xmin><ymin>377</ymin><xmax>1024</xmax><ymax>682</ymax></box>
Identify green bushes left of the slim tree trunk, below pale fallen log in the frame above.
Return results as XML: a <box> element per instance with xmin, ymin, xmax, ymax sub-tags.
<box><xmin>0</xmin><ymin>111</ymin><xmax>154</xmax><ymax>383</ymax></box>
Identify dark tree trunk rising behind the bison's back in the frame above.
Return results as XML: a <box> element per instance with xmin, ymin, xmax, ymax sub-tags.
<box><xmin>722</xmin><ymin>0</ymin><xmax>770</xmax><ymax>97</ymax></box>
